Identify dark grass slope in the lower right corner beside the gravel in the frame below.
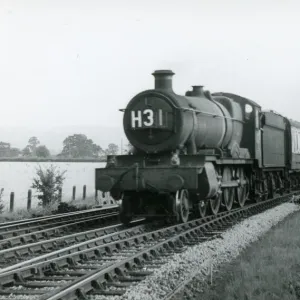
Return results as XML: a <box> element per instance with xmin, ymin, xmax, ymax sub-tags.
<box><xmin>176</xmin><ymin>212</ymin><xmax>300</xmax><ymax>300</ymax></box>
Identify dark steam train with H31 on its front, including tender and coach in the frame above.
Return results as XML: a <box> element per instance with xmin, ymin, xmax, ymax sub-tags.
<box><xmin>95</xmin><ymin>70</ymin><xmax>300</xmax><ymax>224</ymax></box>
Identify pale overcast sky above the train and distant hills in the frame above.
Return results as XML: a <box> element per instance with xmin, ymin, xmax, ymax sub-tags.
<box><xmin>0</xmin><ymin>0</ymin><xmax>300</xmax><ymax>135</ymax></box>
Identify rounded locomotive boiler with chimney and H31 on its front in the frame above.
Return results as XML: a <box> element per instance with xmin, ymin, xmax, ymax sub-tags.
<box><xmin>124</xmin><ymin>70</ymin><xmax>243</xmax><ymax>154</ymax></box>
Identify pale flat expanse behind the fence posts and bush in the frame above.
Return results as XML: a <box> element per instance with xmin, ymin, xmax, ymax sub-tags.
<box><xmin>0</xmin><ymin>162</ymin><xmax>106</xmax><ymax>209</ymax></box>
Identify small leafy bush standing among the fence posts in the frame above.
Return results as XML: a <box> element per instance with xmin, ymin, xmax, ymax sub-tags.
<box><xmin>31</xmin><ymin>165</ymin><xmax>66</xmax><ymax>207</ymax></box>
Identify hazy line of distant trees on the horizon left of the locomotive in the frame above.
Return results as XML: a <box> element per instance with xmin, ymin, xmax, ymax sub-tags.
<box><xmin>0</xmin><ymin>134</ymin><xmax>130</xmax><ymax>158</ymax></box>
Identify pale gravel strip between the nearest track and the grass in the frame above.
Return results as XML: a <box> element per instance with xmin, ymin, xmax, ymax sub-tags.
<box><xmin>91</xmin><ymin>203</ymin><xmax>300</xmax><ymax>300</ymax></box>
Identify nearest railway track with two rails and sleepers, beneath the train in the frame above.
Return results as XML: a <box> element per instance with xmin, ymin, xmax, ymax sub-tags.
<box><xmin>0</xmin><ymin>193</ymin><xmax>295</xmax><ymax>300</ymax></box>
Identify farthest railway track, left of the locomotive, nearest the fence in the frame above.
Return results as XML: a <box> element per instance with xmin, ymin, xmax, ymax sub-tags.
<box><xmin>0</xmin><ymin>206</ymin><xmax>118</xmax><ymax>240</ymax></box>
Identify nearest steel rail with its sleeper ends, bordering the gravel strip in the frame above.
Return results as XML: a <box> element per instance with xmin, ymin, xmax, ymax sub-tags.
<box><xmin>39</xmin><ymin>193</ymin><xmax>292</xmax><ymax>300</ymax></box>
